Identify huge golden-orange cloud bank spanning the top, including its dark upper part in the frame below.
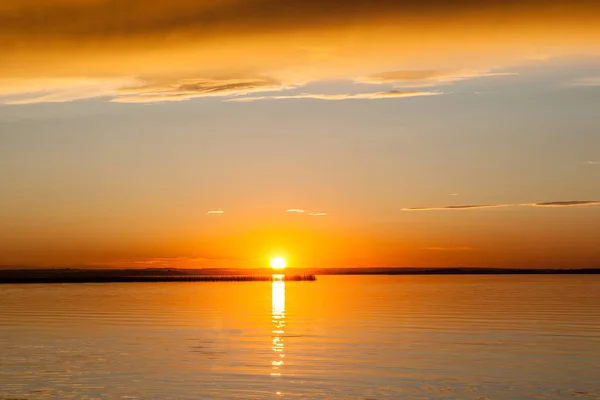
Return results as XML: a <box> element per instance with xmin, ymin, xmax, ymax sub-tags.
<box><xmin>0</xmin><ymin>0</ymin><xmax>600</xmax><ymax>104</ymax></box>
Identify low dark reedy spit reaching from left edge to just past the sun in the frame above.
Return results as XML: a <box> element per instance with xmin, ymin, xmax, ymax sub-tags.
<box><xmin>0</xmin><ymin>274</ymin><xmax>317</xmax><ymax>284</ymax></box>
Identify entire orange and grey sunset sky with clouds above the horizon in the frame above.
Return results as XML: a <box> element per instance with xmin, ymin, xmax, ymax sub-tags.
<box><xmin>0</xmin><ymin>0</ymin><xmax>600</xmax><ymax>268</ymax></box>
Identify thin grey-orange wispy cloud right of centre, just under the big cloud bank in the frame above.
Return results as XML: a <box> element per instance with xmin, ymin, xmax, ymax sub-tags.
<box><xmin>356</xmin><ymin>70</ymin><xmax>516</xmax><ymax>88</ymax></box>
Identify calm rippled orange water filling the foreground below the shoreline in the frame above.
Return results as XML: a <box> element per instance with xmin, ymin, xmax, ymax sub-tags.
<box><xmin>0</xmin><ymin>276</ymin><xmax>600</xmax><ymax>400</ymax></box>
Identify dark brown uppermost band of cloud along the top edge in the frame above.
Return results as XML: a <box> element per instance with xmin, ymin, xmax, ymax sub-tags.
<box><xmin>0</xmin><ymin>0</ymin><xmax>597</xmax><ymax>39</ymax></box>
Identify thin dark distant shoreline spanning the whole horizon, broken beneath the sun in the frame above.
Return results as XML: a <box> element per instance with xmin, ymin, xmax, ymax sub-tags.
<box><xmin>0</xmin><ymin>268</ymin><xmax>600</xmax><ymax>284</ymax></box>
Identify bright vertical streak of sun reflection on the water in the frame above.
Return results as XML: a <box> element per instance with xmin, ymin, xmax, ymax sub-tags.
<box><xmin>271</xmin><ymin>274</ymin><xmax>285</xmax><ymax>382</ymax></box>
